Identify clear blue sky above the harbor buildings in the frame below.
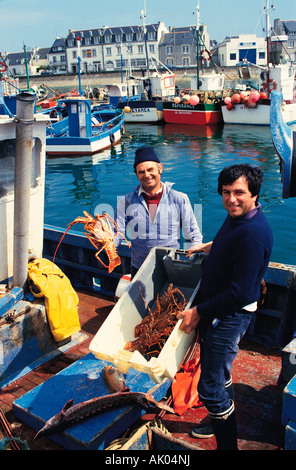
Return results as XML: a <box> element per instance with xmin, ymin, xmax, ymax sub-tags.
<box><xmin>0</xmin><ymin>0</ymin><xmax>296</xmax><ymax>52</ymax></box>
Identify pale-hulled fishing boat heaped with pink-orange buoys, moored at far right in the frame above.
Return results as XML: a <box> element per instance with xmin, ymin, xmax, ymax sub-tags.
<box><xmin>221</xmin><ymin>0</ymin><xmax>296</xmax><ymax>126</ymax></box>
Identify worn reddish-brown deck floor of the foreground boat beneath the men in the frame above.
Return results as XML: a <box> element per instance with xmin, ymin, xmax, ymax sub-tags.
<box><xmin>0</xmin><ymin>292</ymin><xmax>284</xmax><ymax>450</ymax></box>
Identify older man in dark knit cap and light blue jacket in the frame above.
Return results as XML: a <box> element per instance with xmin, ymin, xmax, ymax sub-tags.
<box><xmin>115</xmin><ymin>147</ymin><xmax>202</xmax><ymax>277</ymax></box>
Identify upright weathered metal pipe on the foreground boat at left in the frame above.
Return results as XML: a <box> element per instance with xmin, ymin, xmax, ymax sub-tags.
<box><xmin>13</xmin><ymin>93</ymin><xmax>35</xmax><ymax>288</ymax></box>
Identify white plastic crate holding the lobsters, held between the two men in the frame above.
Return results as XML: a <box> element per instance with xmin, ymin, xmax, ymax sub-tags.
<box><xmin>90</xmin><ymin>248</ymin><xmax>204</xmax><ymax>383</ymax></box>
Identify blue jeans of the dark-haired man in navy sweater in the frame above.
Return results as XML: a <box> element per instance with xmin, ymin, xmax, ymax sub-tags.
<box><xmin>198</xmin><ymin>311</ymin><xmax>253</xmax><ymax>417</ymax></box>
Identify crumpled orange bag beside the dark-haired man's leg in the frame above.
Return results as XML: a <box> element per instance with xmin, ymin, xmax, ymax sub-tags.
<box><xmin>172</xmin><ymin>358</ymin><xmax>203</xmax><ymax>415</ymax></box>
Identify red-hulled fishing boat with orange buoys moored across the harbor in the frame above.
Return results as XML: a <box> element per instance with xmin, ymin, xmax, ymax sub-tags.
<box><xmin>163</xmin><ymin>2</ymin><xmax>225</xmax><ymax>125</ymax></box>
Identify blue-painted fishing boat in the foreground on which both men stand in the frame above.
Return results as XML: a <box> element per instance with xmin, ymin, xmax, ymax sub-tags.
<box><xmin>0</xmin><ymin>92</ymin><xmax>296</xmax><ymax>452</ymax></box>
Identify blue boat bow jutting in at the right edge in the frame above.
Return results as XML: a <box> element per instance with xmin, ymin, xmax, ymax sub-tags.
<box><xmin>270</xmin><ymin>91</ymin><xmax>296</xmax><ymax>199</ymax></box>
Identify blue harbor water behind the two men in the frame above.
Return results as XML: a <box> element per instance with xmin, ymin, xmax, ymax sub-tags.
<box><xmin>44</xmin><ymin>124</ymin><xmax>296</xmax><ymax>265</ymax></box>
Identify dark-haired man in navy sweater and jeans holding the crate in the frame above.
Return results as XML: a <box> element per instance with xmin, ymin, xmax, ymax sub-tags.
<box><xmin>178</xmin><ymin>164</ymin><xmax>273</xmax><ymax>450</ymax></box>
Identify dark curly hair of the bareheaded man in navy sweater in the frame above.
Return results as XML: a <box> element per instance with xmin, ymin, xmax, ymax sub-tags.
<box><xmin>218</xmin><ymin>164</ymin><xmax>263</xmax><ymax>196</ymax></box>
